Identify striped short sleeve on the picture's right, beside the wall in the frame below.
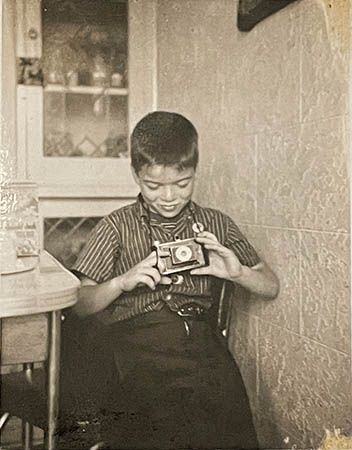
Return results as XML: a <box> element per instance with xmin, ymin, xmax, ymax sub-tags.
<box><xmin>225</xmin><ymin>217</ymin><xmax>260</xmax><ymax>267</ymax></box>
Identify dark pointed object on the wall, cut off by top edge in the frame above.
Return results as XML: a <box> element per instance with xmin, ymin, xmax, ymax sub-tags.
<box><xmin>237</xmin><ymin>0</ymin><xmax>297</xmax><ymax>31</ymax></box>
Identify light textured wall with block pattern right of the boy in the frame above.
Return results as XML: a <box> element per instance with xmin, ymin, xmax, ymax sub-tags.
<box><xmin>157</xmin><ymin>0</ymin><xmax>352</xmax><ymax>448</ymax></box>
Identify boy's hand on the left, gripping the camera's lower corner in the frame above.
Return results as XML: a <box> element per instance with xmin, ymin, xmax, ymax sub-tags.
<box><xmin>121</xmin><ymin>252</ymin><xmax>171</xmax><ymax>292</ymax></box>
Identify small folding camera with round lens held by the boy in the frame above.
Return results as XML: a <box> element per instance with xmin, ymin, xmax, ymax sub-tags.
<box><xmin>154</xmin><ymin>238</ymin><xmax>208</xmax><ymax>275</ymax></box>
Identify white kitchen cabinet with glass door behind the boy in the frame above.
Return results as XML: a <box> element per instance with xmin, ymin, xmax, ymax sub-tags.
<box><xmin>6</xmin><ymin>0</ymin><xmax>157</xmax><ymax>262</ymax></box>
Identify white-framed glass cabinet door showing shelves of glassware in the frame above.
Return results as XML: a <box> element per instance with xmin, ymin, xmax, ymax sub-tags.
<box><xmin>16</xmin><ymin>0</ymin><xmax>140</xmax><ymax>198</ymax></box>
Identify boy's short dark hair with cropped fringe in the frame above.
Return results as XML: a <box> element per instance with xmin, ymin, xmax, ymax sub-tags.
<box><xmin>131</xmin><ymin>111</ymin><xmax>198</xmax><ymax>174</ymax></box>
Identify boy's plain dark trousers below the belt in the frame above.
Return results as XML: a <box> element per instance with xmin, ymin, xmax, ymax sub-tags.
<box><xmin>97</xmin><ymin>308</ymin><xmax>258</xmax><ymax>449</ymax></box>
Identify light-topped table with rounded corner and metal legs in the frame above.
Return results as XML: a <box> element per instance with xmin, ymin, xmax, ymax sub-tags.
<box><xmin>0</xmin><ymin>251</ymin><xmax>80</xmax><ymax>450</ymax></box>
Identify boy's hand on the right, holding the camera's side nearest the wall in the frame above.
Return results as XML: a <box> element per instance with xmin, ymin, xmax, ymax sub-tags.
<box><xmin>191</xmin><ymin>231</ymin><xmax>242</xmax><ymax>281</ymax></box>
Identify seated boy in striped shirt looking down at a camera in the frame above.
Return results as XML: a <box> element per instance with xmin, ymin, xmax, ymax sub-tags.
<box><xmin>68</xmin><ymin>111</ymin><xmax>279</xmax><ymax>449</ymax></box>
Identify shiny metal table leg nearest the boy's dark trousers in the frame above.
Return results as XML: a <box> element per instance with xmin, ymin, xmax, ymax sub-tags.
<box><xmin>46</xmin><ymin>310</ymin><xmax>61</xmax><ymax>450</ymax></box>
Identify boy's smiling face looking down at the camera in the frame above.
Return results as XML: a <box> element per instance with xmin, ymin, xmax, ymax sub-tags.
<box><xmin>133</xmin><ymin>164</ymin><xmax>195</xmax><ymax>218</ymax></box>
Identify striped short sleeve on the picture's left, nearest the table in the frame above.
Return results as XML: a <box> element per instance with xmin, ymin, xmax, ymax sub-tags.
<box><xmin>72</xmin><ymin>219</ymin><xmax>119</xmax><ymax>283</ymax></box>
